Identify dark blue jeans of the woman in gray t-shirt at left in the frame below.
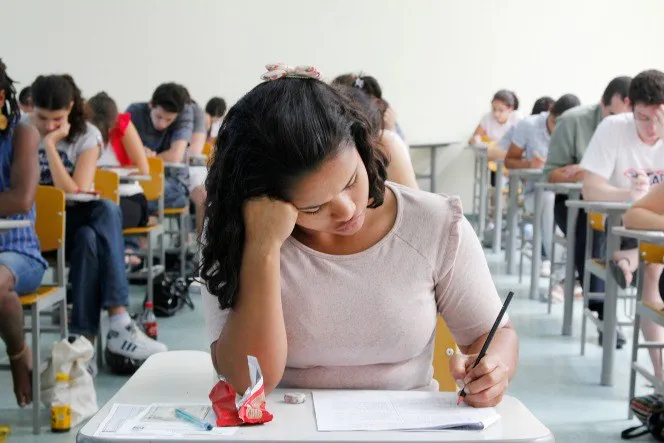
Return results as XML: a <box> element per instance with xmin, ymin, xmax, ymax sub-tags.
<box><xmin>65</xmin><ymin>200</ymin><xmax>129</xmax><ymax>335</ymax></box>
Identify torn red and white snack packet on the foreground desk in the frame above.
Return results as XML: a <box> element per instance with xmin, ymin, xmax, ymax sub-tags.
<box><xmin>209</xmin><ymin>355</ymin><xmax>273</xmax><ymax>427</ymax></box>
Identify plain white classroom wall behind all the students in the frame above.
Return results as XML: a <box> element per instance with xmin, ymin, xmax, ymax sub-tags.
<box><xmin>5</xmin><ymin>0</ymin><xmax>664</xmax><ymax>206</ymax></box>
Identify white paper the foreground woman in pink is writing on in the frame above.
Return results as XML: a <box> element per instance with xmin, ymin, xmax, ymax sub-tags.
<box><xmin>313</xmin><ymin>391</ymin><xmax>500</xmax><ymax>431</ymax></box>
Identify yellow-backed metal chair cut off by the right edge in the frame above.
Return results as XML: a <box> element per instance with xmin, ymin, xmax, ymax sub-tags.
<box><xmin>628</xmin><ymin>242</ymin><xmax>664</xmax><ymax>419</ymax></box>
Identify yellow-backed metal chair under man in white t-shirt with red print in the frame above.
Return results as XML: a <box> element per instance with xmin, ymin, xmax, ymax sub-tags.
<box><xmin>580</xmin><ymin>212</ymin><xmax>634</xmax><ymax>355</ymax></box>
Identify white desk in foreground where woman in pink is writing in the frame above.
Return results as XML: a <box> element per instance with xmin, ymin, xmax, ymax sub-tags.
<box><xmin>76</xmin><ymin>351</ymin><xmax>555</xmax><ymax>443</ymax></box>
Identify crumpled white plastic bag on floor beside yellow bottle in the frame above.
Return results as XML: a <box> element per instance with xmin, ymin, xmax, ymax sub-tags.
<box><xmin>41</xmin><ymin>336</ymin><xmax>99</xmax><ymax>427</ymax></box>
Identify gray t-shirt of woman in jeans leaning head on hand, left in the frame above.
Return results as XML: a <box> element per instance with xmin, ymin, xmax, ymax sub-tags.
<box><xmin>39</xmin><ymin>122</ymin><xmax>104</xmax><ymax>186</ymax></box>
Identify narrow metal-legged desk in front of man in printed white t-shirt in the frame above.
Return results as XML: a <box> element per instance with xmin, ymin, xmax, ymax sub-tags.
<box><xmin>563</xmin><ymin>200</ymin><xmax>631</xmax><ymax>386</ymax></box>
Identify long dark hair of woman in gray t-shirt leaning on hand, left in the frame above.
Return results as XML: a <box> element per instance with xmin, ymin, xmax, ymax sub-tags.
<box><xmin>31</xmin><ymin>74</ymin><xmax>87</xmax><ymax>143</ymax></box>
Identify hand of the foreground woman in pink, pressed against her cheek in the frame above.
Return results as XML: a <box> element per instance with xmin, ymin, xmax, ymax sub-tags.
<box><xmin>242</xmin><ymin>197</ymin><xmax>297</xmax><ymax>251</ymax></box>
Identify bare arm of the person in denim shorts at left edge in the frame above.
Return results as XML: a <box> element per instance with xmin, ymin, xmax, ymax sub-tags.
<box><xmin>0</xmin><ymin>124</ymin><xmax>39</xmax><ymax>217</ymax></box>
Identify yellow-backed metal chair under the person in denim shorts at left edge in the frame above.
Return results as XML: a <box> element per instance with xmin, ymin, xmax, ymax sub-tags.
<box><xmin>1</xmin><ymin>186</ymin><xmax>68</xmax><ymax>434</ymax></box>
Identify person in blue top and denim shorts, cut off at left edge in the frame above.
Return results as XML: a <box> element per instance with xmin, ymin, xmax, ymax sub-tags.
<box><xmin>0</xmin><ymin>60</ymin><xmax>47</xmax><ymax>407</ymax></box>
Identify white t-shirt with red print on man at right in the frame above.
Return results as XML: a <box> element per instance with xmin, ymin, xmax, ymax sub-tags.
<box><xmin>581</xmin><ymin>112</ymin><xmax>664</xmax><ymax>189</ymax></box>
